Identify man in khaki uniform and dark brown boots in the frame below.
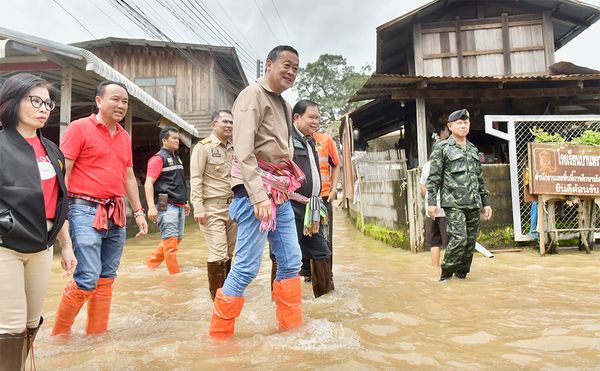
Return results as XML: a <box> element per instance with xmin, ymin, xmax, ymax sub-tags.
<box><xmin>190</xmin><ymin>110</ymin><xmax>237</xmax><ymax>300</ymax></box>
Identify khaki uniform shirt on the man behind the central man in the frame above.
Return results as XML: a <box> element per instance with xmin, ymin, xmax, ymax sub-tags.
<box><xmin>190</xmin><ymin>134</ymin><xmax>234</xmax><ymax>216</ymax></box>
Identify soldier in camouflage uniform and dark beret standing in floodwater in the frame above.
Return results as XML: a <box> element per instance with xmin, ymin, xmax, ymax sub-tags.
<box><xmin>427</xmin><ymin>109</ymin><xmax>492</xmax><ymax>281</ymax></box>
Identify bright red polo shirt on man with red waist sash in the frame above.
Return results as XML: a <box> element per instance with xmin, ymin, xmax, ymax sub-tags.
<box><xmin>60</xmin><ymin>114</ymin><xmax>133</xmax><ymax>198</ymax></box>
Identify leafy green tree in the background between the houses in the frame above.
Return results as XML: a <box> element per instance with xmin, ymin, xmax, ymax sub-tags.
<box><xmin>296</xmin><ymin>54</ymin><xmax>371</xmax><ymax>135</ymax></box>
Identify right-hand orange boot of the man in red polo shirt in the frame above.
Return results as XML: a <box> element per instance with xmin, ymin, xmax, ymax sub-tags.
<box><xmin>85</xmin><ymin>277</ymin><xmax>115</xmax><ymax>335</ymax></box>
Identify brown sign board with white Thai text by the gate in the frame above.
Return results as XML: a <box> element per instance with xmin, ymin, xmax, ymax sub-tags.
<box><xmin>529</xmin><ymin>143</ymin><xmax>600</xmax><ymax>196</ymax></box>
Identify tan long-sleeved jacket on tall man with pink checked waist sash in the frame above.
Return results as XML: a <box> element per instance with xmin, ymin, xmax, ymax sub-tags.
<box><xmin>231</xmin><ymin>78</ymin><xmax>292</xmax><ymax>204</ymax></box>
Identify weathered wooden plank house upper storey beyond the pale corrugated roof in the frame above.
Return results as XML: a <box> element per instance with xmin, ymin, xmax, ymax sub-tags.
<box><xmin>73</xmin><ymin>37</ymin><xmax>248</xmax><ymax>138</ymax></box>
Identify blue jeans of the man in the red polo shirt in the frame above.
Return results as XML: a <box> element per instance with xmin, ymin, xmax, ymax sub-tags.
<box><xmin>68</xmin><ymin>204</ymin><xmax>125</xmax><ymax>291</ymax></box>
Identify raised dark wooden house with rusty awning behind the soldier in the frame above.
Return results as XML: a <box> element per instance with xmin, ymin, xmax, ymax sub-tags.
<box><xmin>341</xmin><ymin>0</ymin><xmax>600</xmax><ymax>168</ymax></box>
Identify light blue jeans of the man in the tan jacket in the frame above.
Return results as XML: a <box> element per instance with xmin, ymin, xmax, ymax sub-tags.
<box><xmin>221</xmin><ymin>197</ymin><xmax>302</xmax><ymax>296</ymax></box>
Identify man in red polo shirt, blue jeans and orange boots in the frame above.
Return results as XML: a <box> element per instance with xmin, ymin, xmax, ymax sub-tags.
<box><xmin>52</xmin><ymin>81</ymin><xmax>148</xmax><ymax>335</ymax></box>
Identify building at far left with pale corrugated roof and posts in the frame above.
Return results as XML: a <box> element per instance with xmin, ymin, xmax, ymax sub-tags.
<box><xmin>0</xmin><ymin>28</ymin><xmax>199</xmax><ymax>179</ymax></box>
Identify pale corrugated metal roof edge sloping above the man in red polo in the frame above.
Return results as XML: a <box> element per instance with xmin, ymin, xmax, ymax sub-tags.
<box><xmin>0</xmin><ymin>27</ymin><xmax>198</xmax><ymax>138</ymax></box>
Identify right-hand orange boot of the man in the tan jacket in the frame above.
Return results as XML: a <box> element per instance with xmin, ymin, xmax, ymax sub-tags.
<box><xmin>273</xmin><ymin>276</ymin><xmax>302</xmax><ymax>331</ymax></box>
